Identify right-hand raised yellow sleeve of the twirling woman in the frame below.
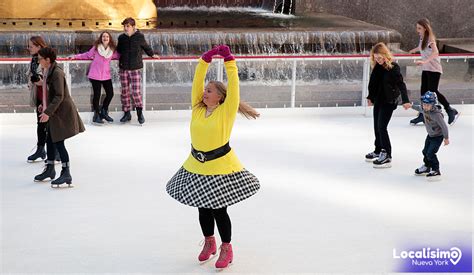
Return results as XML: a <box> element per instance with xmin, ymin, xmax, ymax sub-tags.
<box><xmin>223</xmin><ymin>60</ymin><xmax>240</xmax><ymax>115</ymax></box>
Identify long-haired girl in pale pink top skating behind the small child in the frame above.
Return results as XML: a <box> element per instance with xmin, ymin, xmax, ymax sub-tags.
<box><xmin>409</xmin><ymin>19</ymin><xmax>459</xmax><ymax>125</ymax></box>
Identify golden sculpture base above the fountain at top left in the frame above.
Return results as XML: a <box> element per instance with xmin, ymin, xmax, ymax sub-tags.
<box><xmin>0</xmin><ymin>0</ymin><xmax>157</xmax><ymax>28</ymax></box>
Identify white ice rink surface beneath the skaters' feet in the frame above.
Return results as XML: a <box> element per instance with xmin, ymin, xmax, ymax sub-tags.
<box><xmin>0</xmin><ymin>105</ymin><xmax>474</xmax><ymax>274</ymax></box>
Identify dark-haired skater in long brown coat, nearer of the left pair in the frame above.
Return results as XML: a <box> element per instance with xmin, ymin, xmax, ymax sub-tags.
<box><xmin>35</xmin><ymin>48</ymin><xmax>85</xmax><ymax>187</ymax></box>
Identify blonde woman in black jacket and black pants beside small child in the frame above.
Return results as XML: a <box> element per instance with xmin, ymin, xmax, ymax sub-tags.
<box><xmin>365</xmin><ymin>43</ymin><xmax>410</xmax><ymax>168</ymax></box>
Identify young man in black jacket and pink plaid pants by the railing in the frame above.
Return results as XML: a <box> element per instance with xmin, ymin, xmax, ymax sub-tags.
<box><xmin>117</xmin><ymin>17</ymin><xmax>159</xmax><ymax>124</ymax></box>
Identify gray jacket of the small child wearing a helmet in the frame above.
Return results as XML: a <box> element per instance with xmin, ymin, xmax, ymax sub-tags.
<box><xmin>411</xmin><ymin>105</ymin><xmax>449</xmax><ymax>139</ymax></box>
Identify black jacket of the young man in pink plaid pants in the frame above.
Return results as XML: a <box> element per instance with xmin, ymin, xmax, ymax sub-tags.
<box><xmin>117</xmin><ymin>30</ymin><xmax>154</xmax><ymax>70</ymax></box>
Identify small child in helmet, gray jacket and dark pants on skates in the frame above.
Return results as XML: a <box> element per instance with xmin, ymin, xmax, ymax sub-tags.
<box><xmin>412</xmin><ymin>91</ymin><xmax>449</xmax><ymax>180</ymax></box>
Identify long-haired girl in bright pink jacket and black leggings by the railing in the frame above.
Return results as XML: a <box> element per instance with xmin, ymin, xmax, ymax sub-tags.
<box><xmin>74</xmin><ymin>31</ymin><xmax>119</xmax><ymax>125</ymax></box>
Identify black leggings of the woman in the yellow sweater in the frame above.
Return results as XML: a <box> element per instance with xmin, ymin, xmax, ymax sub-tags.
<box><xmin>198</xmin><ymin>207</ymin><xmax>232</xmax><ymax>243</ymax></box>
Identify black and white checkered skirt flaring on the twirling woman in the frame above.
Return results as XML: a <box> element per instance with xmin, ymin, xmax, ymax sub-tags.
<box><xmin>166</xmin><ymin>167</ymin><xmax>260</xmax><ymax>209</ymax></box>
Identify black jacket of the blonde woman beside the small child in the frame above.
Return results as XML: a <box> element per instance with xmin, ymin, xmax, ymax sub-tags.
<box><xmin>367</xmin><ymin>63</ymin><xmax>410</xmax><ymax>104</ymax></box>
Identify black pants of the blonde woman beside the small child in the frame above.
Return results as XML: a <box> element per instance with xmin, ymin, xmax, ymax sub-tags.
<box><xmin>374</xmin><ymin>103</ymin><xmax>397</xmax><ymax>157</ymax></box>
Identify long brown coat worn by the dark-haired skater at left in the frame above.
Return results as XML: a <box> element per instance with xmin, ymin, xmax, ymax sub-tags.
<box><xmin>44</xmin><ymin>63</ymin><xmax>85</xmax><ymax>142</ymax></box>
